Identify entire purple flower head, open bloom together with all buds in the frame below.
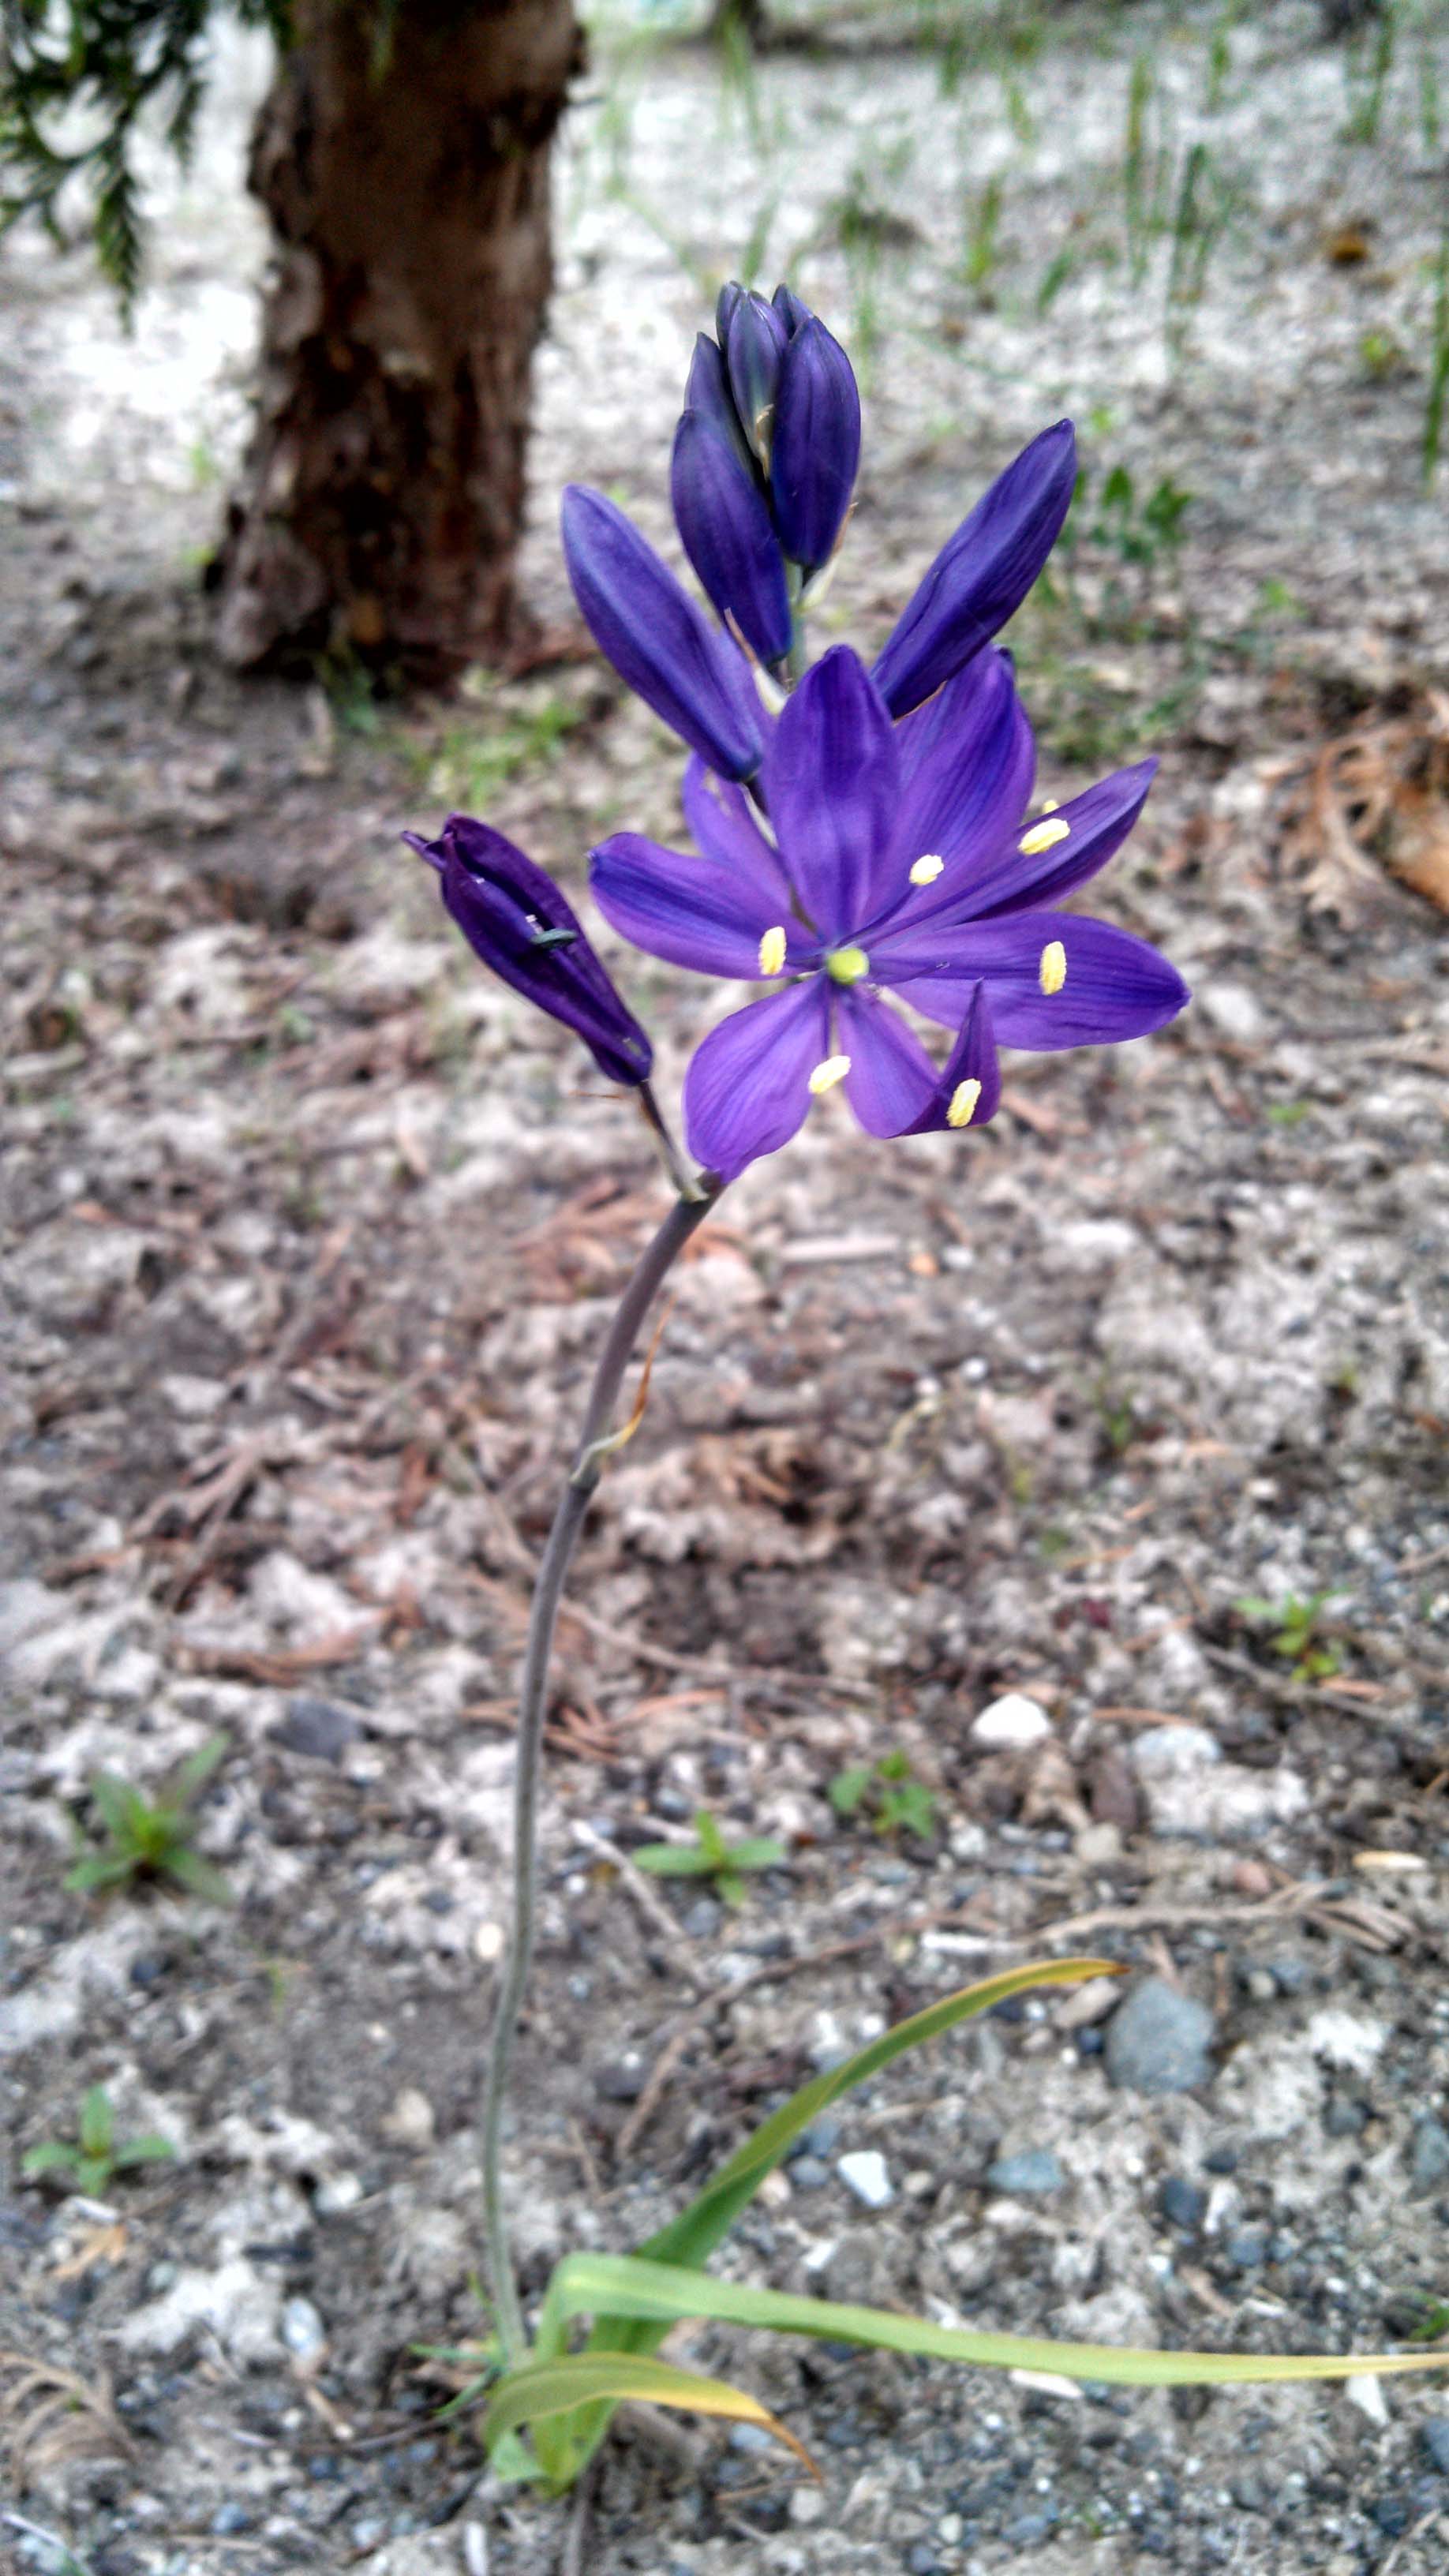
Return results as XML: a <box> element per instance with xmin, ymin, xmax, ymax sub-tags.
<box><xmin>405</xmin><ymin>286</ymin><xmax>1186</xmax><ymax>1180</ymax></box>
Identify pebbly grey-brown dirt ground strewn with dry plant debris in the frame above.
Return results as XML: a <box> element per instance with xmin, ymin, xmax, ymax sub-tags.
<box><xmin>0</xmin><ymin>6</ymin><xmax>1449</xmax><ymax>2576</ymax></box>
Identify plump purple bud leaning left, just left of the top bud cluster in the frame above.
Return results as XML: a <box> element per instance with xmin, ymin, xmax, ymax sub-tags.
<box><xmin>562</xmin><ymin>485</ymin><xmax>766</xmax><ymax>778</ymax></box>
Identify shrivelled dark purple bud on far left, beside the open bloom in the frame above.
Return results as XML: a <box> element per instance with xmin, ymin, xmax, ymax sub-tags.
<box><xmin>402</xmin><ymin>814</ymin><xmax>655</xmax><ymax>1084</ymax></box>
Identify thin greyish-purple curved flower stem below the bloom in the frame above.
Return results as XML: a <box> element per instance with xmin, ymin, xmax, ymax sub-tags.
<box><xmin>480</xmin><ymin>1182</ymin><xmax>719</xmax><ymax>2368</ymax></box>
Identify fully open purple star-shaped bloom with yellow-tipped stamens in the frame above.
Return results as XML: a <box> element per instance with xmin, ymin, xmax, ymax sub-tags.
<box><xmin>590</xmin><ymin>644</ymin><xmax>1189</xmax><ymax>1180</ymax></box>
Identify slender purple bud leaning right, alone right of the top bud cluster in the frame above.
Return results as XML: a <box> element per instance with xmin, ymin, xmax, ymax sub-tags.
<box><xmin>871</xmin><ymin>420</ymin><xmax>1078</xmax><ymax>716</ymax></box>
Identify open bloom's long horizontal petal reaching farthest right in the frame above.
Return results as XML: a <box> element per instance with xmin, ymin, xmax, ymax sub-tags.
<box><xmin>871</xmin><ymin>912</ymin><xmax>1189</xmax><ymax>1054</ymax></box>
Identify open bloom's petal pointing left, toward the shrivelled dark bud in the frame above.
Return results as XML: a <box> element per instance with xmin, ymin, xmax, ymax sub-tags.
<box><xmin>588</xmin><ymin>832</ymin><xmax>818</xmax><ymax>984</ymax></box>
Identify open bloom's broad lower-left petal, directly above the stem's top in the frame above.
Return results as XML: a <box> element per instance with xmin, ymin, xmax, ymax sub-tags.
<box><xmin>683</xmin><ymin>976</ymin><xmax>830</xmax><ymax>1180</ymax></box>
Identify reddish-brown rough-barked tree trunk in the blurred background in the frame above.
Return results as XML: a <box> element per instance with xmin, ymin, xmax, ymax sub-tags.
<box><xmin>214</xmin><ymin>0</ymin><xmax>580</xmax><ymax>680</ymax></box>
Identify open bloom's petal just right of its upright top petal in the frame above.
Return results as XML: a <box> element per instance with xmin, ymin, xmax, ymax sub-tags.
<box><xmin>861</xmin><ymin>652</ymin><xmax>1036</xmax><ymax>930</ymax></box>
